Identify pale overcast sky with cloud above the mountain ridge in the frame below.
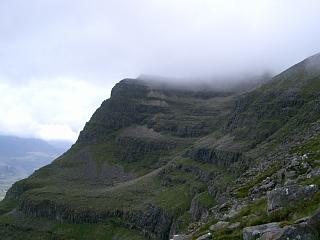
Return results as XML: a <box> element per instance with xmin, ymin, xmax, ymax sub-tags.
<box><xmin>0</xmin><ymin>0</ymin><xmax>320</xmax><ymax>141</ymax></box>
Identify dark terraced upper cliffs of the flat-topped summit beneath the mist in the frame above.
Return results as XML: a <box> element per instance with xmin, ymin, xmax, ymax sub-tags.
<box><xmin>77</xmin><ymin>79</ymin><xmax>231</xmax><ymax>144</ymax></box>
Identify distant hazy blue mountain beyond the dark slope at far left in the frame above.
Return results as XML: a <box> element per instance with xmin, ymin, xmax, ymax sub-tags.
<box><xmin>0</xmin><ymin>136</ymin><xmax>67</xmax><ymax>199</ymax></box>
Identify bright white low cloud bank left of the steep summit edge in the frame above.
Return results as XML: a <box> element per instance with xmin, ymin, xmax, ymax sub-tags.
<box><xmin>0</xmin><ymin>78</ymin><xmax>109</xmax><ymax>141</ymax></box>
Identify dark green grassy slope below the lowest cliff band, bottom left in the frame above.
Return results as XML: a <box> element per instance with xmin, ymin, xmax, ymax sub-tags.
<box><xmin>0</xmin><ymin>214</ymin><xmax>146</xmax><ymax>240</ymax></box>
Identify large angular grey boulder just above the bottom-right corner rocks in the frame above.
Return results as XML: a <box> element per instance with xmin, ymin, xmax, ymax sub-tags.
<box><xmin>267</xmin><ymin>185</ymin><xmax>318</xmax><ymax>212</ymax></box>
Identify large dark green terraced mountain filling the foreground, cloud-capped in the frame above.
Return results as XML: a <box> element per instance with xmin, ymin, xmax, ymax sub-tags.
<box><xmin>0</xmin><ymin>54</ymin><xmax>320</xmax><ymax>240</ymax></box>
